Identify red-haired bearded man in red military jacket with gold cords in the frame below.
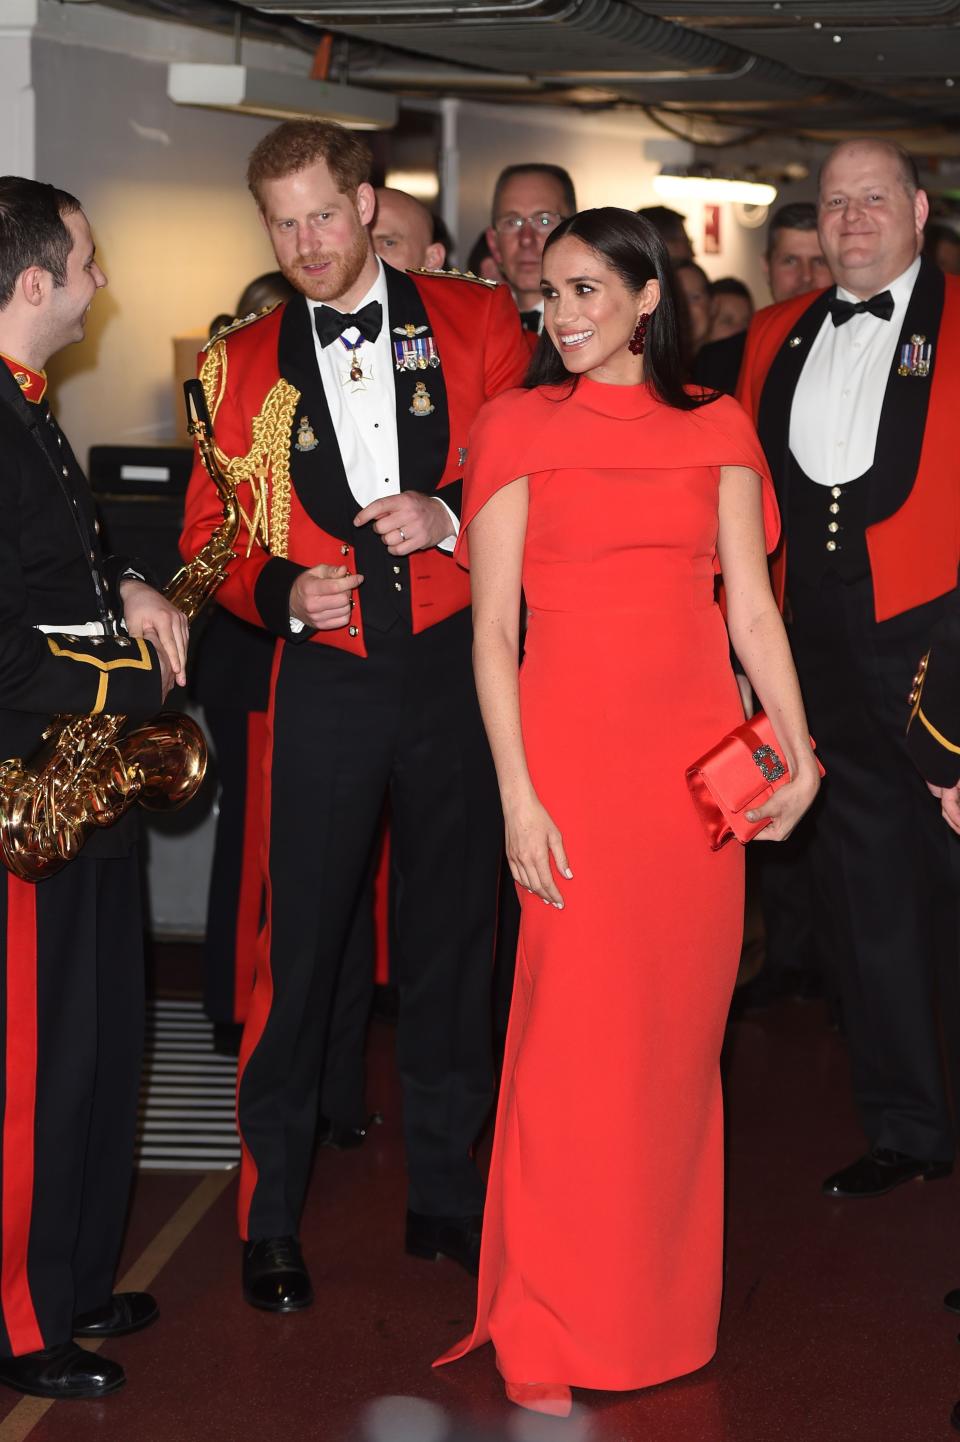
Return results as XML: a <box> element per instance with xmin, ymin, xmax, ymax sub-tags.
<box><xmin>182</xmin><ymin>121</ymin><xmax>528</xmax><ymax>1312</ymax></box>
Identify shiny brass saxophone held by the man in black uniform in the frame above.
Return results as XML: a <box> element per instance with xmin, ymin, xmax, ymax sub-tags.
<box><xmin>0</xmin><ymin>381</ymin><xmax>241</xmax><ymax>881</ymax></box>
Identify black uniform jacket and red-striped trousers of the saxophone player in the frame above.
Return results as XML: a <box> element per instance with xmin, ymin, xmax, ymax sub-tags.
<box><xmin>0</xmin><ymin>366</ymin><xmax>161</xmax><ymax>1355</ymax></box>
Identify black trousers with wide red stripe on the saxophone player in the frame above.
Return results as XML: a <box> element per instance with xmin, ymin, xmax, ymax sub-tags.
<box><xmin>0</xmin><ymin>855</ymin><xmax>144</xmax><ymax>1357</ymax></box>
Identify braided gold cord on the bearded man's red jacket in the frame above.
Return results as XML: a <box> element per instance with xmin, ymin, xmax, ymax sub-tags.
<box><xmin>200</xmin><ymin>339</ymin><xmax>300</xmax><ymax>557</ymax></box>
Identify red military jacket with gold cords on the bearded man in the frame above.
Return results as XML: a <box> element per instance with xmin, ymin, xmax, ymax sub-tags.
<box><xmin>180</xmin><ymin>265</ymin><xmax>528</xmax><ymax>656</ymax></box>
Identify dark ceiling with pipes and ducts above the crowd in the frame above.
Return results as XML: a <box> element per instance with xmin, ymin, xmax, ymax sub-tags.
<box><xmin>238</xmin><ymin>0</ymin><xmax>960</xmax><ymax>143</ymax></box>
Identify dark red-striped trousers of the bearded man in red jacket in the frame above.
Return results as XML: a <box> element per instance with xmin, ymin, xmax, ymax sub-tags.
<box><xmin>238</xmin><ymin>611</ymin><xmax>502</xmax><ymax>1237</ymax></box>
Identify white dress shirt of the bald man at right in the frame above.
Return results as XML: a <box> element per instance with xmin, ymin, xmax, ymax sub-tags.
<box><xmin>790</xmin><ymin>257</ymin><xmax>920</xmax><ymax>486</ymax></box>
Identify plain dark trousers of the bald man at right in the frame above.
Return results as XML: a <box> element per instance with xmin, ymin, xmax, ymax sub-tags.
<box><xmin>788</xmin><ymin>578</ymin><xmax>957</xmax><ymax>1161</ymax></box>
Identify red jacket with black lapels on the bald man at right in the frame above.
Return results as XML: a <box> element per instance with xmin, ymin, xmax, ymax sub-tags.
<box><xmin>738</xmin><ymin>260</ymin><xmax>960</xmax><ymax>622</ymax></box>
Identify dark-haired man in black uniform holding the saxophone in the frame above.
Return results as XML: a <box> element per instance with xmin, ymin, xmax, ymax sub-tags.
<box><xmin>0</xmin><ymin>176</ymin><xmax>187</xmax><ymax>1399</ymax></box>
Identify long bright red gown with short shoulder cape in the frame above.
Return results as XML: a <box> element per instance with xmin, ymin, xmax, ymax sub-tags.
<box><xmin>438</xmin><ymin>378</ymin><xmax>778</xmax><ymax>1390</ymax></box>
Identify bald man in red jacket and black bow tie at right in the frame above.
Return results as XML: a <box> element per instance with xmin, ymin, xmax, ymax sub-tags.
<box><xmin>741</xmin><ymin>140</ymin><xmax>960</xmax><ymax>1198</ymax></box>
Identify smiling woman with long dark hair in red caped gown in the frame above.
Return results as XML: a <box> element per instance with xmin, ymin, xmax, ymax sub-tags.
<box><xmin>432</xmin><ymin>209</ymin><xmax>819</xmax><ymax>1416</ymax></box>
